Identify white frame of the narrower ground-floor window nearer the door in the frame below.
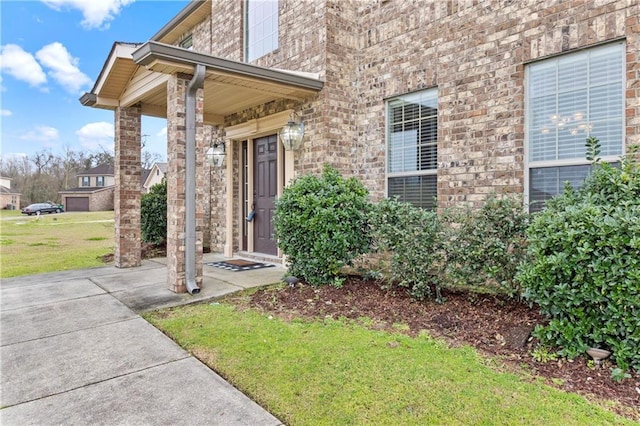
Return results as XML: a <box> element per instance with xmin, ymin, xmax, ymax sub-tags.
<box><xmin>385</xmin><ymin>87</ymin><xmax>440</xmax><ymax>209</ymax></box>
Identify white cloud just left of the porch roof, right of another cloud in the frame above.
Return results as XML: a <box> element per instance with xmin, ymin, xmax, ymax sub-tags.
<box><xmin>36</xmin><ymin>42</ymin><xmax>91</xmax><ymax>93</ymax></box>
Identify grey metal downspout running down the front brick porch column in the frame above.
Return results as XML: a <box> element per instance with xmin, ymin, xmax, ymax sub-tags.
<box><xmin>185</xmin><ymin>64</ymin><xmax>206</xmax><ymax>295</ymax></box>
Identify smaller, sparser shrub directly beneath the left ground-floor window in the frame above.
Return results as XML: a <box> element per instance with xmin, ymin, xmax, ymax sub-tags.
<box><xmin>371</xmin><ymin>200</ymin><xmax>444</xmax><ymax>302</ymax></box>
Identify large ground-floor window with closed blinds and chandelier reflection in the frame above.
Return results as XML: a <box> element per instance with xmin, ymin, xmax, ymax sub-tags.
<box><xmin>525</xmin><ymin>43</ymin><xmax>625</xmax><ymax>211</ymax></box>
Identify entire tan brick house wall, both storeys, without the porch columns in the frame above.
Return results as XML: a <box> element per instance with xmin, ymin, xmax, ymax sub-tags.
<box><xmin>166</xmin><ymin>0</ymin><xmax>640</xmax><ymax>250</ymax></box>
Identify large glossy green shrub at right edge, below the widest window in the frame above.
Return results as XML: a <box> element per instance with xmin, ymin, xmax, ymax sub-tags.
<box><xmin>517</xmin><ymin>139</ymin><xmax>640</xmax><ymax>371</ymax></box>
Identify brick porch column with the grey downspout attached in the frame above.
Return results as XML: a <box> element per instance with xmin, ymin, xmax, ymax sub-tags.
<box><xmin>167</xmin><ymin>74</ymin><xmax>207</xmax><ymax>293</ymax></box>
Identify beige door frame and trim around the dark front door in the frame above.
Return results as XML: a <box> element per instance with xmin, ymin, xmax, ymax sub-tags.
<box><xmin>224</xmin><ymin>109</ymin><xmax>294</xmax><ymax>257</ymax></box>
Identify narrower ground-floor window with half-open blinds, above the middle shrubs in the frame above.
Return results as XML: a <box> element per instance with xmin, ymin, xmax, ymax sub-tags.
<box><xmin>387</xmin><ymin>89</ymin><xmax>438</xmax><ymax>209</ymax></box>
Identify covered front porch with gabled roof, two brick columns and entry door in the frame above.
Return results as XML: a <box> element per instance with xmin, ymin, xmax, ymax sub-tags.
<box><xmin>81</xmin><ymin>41</ymin><xmax>323</xmax><ymax>293</ymax></box>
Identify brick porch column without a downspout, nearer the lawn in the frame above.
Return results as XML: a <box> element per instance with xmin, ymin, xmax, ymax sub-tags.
<box><xmin>113</xmin><ymin>106</ymin><xmax>141</xmax><ymax>268</ymax></box>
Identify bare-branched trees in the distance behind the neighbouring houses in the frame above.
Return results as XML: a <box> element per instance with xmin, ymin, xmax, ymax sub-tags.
<box><xmin>0</xmin><ymin>149</ymin><xmax>162</xmax><ymax>208</ymax></box>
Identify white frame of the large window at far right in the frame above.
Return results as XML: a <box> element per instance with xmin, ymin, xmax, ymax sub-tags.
<box><xmin>524</xmin><ymin>41</ymin><xmax>626</xmax><ymax>211</ymax></box>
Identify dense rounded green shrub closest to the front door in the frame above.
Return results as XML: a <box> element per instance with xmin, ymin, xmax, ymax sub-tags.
<box><xmin>274</xmin><ymin>165</ymin><xmax>371</xmax><ymax>287</ymax></box>
